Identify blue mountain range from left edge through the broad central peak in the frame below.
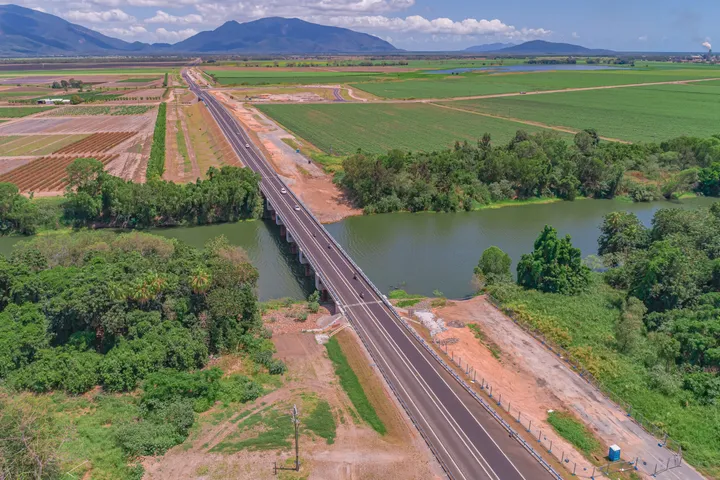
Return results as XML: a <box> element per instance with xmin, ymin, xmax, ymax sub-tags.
<box><xmin>0</xmin><ymin>5</ymin><xmax>398</xmax><ymax>57</ymax></box>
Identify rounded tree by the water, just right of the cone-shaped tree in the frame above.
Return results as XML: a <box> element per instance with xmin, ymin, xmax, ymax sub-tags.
<box><xmin>598</xmin><ymin>212</ymin><xmax>649</xmax><ymax>266</ymax></box>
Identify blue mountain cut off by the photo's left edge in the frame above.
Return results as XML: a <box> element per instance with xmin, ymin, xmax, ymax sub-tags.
<box><xmin>0</xmin><ymin>5</ymin><xmax>148</xmax><ymax>56</ymax></box>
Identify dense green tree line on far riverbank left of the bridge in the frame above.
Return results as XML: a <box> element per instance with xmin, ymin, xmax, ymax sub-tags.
<box><xmin>0</xmin><ymin>158</ymin><xmax>263</xmax><ymax>235</ymax></box>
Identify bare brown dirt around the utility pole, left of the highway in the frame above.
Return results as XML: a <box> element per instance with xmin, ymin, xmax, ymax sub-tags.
<box><xmin>143</xmin><ymin>312</ymin><xmax>440</xmax><ymax>480</ymax></box>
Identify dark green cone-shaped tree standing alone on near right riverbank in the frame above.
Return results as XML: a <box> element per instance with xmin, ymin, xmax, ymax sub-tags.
<box><xmin>517</xmin><ymin>225</ymin><xmax>590</xmax><ymax>295</ymax></box>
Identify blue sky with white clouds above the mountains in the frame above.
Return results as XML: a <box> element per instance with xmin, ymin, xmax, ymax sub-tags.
<box><xmin>7</xmin><ymin>0</ymin><xmax>720</xmax><ymax>52</ymax></box>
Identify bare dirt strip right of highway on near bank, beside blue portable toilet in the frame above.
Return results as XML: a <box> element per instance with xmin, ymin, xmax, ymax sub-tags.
<box><xmin>435</xmin><ymin>296</ymin><xmax>700</xmax><ymax>479</ymax></box>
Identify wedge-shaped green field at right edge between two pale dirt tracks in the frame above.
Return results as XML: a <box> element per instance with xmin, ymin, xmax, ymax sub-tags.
<box><xmin>447</xmin><ymin>82</ymin><xmax>720</xmax><ymax>142</ymax></box>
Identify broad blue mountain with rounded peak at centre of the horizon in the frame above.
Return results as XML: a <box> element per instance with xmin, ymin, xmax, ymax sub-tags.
<box><xmin>172</xmin><ymin>17</ymin><xmax>397</xmax><ymax>53</ymax></box>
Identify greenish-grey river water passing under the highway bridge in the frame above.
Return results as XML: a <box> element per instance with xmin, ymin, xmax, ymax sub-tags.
<box><xmin>0</xmin><ymin>198</ymin><xmax>715</xmax><ymax>300</ymax></box>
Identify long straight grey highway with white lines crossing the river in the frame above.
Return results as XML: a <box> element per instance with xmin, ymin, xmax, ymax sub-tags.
<box><xmin>183</xmin><ymin>71</ymin><xmax>554</xmax><ymax>480</ymax></box>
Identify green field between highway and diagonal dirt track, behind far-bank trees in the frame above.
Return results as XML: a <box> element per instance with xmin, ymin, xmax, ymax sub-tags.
<box><xmin>257</xmin><ymin>103</ymin><xmax>564</xmax><ymax>155</ymax></box>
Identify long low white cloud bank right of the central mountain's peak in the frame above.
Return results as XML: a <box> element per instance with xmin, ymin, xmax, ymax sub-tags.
<box><xmin>311</xmin><ymin>15</ymin><xmax>552</xmax><ymax>39</ymax></box>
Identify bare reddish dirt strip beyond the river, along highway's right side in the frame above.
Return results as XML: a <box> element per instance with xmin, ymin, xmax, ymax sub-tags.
<box><xmin>213</xmin><ymin>91</ymin><xmax>362</xmax><ymax>223</ymax></box>
